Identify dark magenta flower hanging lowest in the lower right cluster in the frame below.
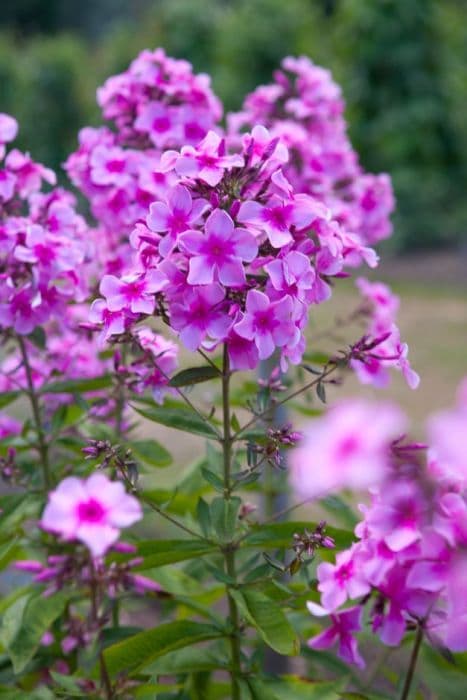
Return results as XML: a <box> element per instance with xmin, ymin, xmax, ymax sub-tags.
<box><xmin>307</xmin><ymin>601</ymin><xmax>365</xmax><ymax>668</ymax></box>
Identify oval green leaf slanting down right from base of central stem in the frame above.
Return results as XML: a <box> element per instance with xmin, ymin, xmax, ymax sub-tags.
<box><xmin>231</xmin><ymin>589</ymin><xmax>300</xmax><ymax>656</ymax></box>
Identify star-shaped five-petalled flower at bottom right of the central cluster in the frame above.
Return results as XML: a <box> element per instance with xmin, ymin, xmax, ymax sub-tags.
<box><xmin>234</xmin><ymin>289</ymin><xmax>299</xmax><ymax>360</ymax></box>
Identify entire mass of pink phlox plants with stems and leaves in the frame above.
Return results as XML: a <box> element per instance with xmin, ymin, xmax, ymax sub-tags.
<box><xmin>0</xmin><ymin>49</ymin><xmax>467</xmax><ymax>700</ymax></box>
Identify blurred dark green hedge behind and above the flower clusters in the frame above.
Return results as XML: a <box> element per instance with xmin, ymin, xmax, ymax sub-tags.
<box><xmin>0</xmin><ymin>0</ymin><xmax>467</xmax><ymax>251</ymax></box>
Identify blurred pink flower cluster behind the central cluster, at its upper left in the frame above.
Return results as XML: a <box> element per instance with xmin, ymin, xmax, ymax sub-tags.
<box><xmin>66</xmin><ymin>49</ymin><xmax>222</xmax><ymax>252</ymax></box>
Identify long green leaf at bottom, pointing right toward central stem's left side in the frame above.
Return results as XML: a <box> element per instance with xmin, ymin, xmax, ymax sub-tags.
<box><xmin>104</xmin><ymin>620</ymin><xmax>222</xmax><ymax>677</ymax></box>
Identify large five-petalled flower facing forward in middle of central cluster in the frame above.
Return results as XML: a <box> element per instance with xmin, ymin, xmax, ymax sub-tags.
<box><xmin>180</xmin><ymin>209</ymin><xmax>258</xmax><ymax>287</ymax></box>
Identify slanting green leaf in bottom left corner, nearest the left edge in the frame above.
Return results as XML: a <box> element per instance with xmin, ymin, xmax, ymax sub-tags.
<box><xmin>6</xmin><ymin>593</ymin><xmax>67</xmax><ymax>673</ymax></box>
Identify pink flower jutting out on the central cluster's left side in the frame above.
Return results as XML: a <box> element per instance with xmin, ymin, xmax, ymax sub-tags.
<box><xmin>99</xmin><ymin>269</ymin><xmax>168</xmax><ymax>314</ymax></box>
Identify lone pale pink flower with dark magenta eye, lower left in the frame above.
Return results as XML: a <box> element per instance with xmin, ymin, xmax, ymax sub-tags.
<box><xmin>41</xmin><ymin>473</ymin><xmax>142</xmax><ymax>557</ymax></box>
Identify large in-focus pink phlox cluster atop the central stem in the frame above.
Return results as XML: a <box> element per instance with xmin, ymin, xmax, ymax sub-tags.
<box><xmin>93</xmin><ymin>127</ymin><xmax>377</xmax><ymax>369</ymax></box>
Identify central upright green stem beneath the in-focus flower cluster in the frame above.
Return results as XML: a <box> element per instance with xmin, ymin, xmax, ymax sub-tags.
<box><xmin>222</xmin><ymin>344</ymin><xmax>242</xmax><ymax>700</ymax></box>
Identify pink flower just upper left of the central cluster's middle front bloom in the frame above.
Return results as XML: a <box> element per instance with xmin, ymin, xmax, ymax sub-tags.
<box><xmin>146</xmin><ymin>185</ymin><xmax>209</xmax><ymax>257</ymax></box>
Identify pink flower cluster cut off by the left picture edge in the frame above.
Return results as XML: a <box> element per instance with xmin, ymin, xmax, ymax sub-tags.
<box><xmin>0</xmin><ymin>115</ymin><xmax>90</xmax><ymax>335</ymax></box>
